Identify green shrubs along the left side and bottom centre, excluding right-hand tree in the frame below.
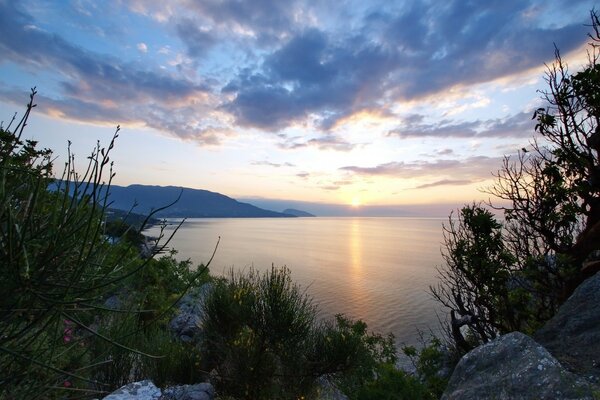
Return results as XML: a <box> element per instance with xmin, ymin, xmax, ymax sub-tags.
<box><xmin>0</xmin><ymin>90</ymin><xmax>440</xmax><ymax>399</ymax></box>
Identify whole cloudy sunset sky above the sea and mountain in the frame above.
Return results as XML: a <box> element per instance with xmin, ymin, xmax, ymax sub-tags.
<box><xmin>0</xmin><ymin>0</ymin><xmax>598</xmax><ymax>214</ymax></box>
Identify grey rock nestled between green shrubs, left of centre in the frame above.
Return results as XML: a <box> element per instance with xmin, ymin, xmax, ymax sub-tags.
<box><xmin>169</xmin><ymin>283</ymin><xmax>213</xmax><ymax>343</ymax></box>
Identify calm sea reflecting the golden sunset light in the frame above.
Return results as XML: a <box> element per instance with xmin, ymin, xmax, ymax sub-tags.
<box><xmin>146</xmin><ymin>218</ymin><xmax>443</xmax><ymax>344</ymax></box>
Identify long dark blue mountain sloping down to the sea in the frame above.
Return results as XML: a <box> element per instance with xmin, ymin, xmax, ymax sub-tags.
<box><xmin>109</xmin><ymin>185</ymin><xmax>294</xmax><ymax>218</ymax></box>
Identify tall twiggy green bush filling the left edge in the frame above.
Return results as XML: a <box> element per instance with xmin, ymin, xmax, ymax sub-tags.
<box><xmin>0</xmin><ymin>91</ymin><xmax>201</xmax><ymax>399</ymax></box>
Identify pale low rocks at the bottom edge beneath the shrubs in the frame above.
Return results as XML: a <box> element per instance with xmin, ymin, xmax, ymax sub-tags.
<box><xmin>104</xmin><ymin>380</ymin><xmax>215</xmax><ymax>400</ymax></box>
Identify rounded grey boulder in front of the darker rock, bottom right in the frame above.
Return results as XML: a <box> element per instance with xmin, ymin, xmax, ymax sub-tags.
<box><xmin>442</xmin><ymin>332</ymin><xmax>594</xmax><ymax>400</ymax></box>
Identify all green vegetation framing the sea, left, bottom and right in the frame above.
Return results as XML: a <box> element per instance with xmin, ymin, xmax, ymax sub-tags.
<box><xmin>0</xmin><ymin>12</ymin><xmax>600</xmax><ymax>399</ymax></box>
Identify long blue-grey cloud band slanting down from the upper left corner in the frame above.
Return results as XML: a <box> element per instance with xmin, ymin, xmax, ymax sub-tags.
<box><xmin>0</xmin><ymin>2</ymin><xmax>230</xmax><ymax>144</ymax></box>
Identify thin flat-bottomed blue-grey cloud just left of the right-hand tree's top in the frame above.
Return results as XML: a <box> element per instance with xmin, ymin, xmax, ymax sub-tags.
<box><xmin>388</xmin><ymin>112</ymin><xmax>535</xmax><ymax>139</ymax></box>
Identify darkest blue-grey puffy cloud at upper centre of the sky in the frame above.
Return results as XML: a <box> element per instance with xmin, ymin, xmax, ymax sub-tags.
<box><xmin>225</xmin><ymin>29</ymin><xmax>393</xmax><ymax>130</ymax></box>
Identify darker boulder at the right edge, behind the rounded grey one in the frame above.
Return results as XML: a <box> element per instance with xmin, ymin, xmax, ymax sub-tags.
<box><xmin>534</xmin><ymin>274</ymin><xmax>600</xmax><ymax>383</ymax></box>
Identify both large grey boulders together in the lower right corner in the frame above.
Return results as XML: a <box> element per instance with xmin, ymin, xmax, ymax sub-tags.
<box><xmin>442</xmin><ymin>274</ymin><xmax>600</xmax><ymax>400</ymax></box>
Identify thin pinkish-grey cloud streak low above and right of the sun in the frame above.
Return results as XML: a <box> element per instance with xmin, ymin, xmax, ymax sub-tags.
<box><xmin>340</xmin><ymin>156</ymin><xmax>502</xmax><ymax>181</ymax></box>
